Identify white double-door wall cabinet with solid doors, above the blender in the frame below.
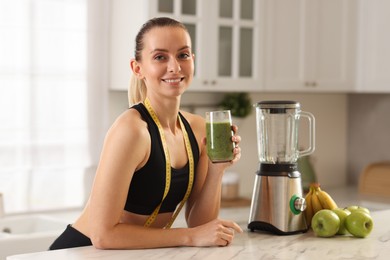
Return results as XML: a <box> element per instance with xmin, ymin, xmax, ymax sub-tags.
<box><xmin>265</xmin><ymin>0</ymin><xmax>356</xmax><ymax>92</ymax></box>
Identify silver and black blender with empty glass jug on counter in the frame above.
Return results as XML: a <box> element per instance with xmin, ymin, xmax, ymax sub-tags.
<box><xmin>248</xmin><ymin>100</ymin><xmax>315</xmax><ymax>235</ymax></box>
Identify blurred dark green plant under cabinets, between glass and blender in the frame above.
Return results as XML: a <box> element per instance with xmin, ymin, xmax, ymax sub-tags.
<box><xmin>219</xmin><ymin>92</ymin><xmax>253</xmax><ymax>118</ymax></box>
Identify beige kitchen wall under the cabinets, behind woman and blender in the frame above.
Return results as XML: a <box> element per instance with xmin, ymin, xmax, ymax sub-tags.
<box><xmin>109</xmin><ymin>91</ymin><xmax>348</xmax><ymax>197</ymax></box>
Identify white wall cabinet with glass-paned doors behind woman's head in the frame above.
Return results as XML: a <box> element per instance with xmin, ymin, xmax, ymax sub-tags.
<box><xmin>110</xmin><ymin>0</ymin><xmax>265</xmax><ymax>91</ymax></box>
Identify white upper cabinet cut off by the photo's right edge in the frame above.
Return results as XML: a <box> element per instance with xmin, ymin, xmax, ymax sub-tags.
<box><xmin>356</xmin><ymin>0</ymin><xmax>390</xmax><ymax>93</ymax></box>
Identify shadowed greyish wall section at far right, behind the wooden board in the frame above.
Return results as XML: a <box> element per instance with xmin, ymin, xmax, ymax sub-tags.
<box><xmin>347</xmin><ymin>94</ymin><xmax>390</xmax><ymax>184</ymax></box>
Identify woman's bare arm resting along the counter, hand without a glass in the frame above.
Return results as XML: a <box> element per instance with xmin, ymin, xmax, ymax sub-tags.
<box><xmin>86</xmin><ymin>110</ymin><xmax>241</xmax><ymax>249</ymax></box>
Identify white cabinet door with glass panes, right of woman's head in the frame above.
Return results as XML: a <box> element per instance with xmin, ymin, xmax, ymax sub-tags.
<box><xmin>205</xmin><ymin>0</ymin><xmax>264</xmax><ymax>91</ymax></box>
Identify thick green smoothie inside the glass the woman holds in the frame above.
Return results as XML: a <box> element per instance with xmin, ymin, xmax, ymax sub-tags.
<box><xmin>206</xmin><ymin>122</ymin><xmax>234</xmax><ymax>162</ymax></box>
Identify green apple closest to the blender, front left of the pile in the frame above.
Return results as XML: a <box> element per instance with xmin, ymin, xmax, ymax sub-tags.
<box><xmin>311</xmin><ymin>209</ymin><xmax>340</xmax><ymax>237</ymax></box>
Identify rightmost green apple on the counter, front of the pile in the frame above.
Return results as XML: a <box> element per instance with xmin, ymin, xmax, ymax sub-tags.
<box><xmin>345</xmin><ymin>210</ymin><xmax>374</xmax><ymax>237</ymax></box>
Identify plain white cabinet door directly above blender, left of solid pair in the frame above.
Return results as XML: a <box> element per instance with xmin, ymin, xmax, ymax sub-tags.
<box><xmin>265</xmin><ymin>0</ymin><xmax>309</xmax><ymax>90</ymax></box>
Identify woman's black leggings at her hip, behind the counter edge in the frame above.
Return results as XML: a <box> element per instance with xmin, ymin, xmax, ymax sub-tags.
<box><xmin>49</xmin><ymin>225</ymin><xmax>92</xmax><ymax>250</ymax></box>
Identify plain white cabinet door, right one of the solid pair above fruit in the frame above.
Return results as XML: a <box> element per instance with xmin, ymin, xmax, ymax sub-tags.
<box><xmin>310</xmin><ymin>0</ymin><xmax>356</xmax><ymax>92</ymax></box>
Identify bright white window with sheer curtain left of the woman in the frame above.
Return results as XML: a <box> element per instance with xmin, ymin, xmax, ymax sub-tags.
<box><xmin>0</xmin><ymin>0</ymin><xmax>93</xmax><ymax>213</ymax></box>
